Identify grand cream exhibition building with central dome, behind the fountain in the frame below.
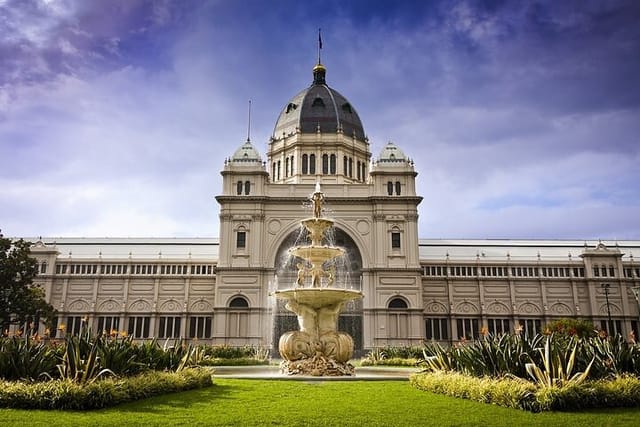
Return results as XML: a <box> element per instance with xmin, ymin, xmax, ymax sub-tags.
<box><xmin>22</xmin><ymin>59</ymin><xmax>640</xmax><ymax>354</ymax></box>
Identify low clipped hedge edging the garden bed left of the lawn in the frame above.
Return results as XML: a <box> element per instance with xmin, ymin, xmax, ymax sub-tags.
<box><xmin>0</xmin><ymin>369</ymin><xmax>213</xmax><ymax>410</ymax></box>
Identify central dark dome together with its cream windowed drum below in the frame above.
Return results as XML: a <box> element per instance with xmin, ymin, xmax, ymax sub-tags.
<box><xmin>267</xmin><ymin>62</ymin><xmax>371</xmax><ymax>184</ymax></box>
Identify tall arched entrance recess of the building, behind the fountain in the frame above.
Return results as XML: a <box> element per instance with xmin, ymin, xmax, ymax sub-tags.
<box><xmin>273</xmin><ymin>227</ymin><xmax>366</xmax><ymax>357</ymax></box>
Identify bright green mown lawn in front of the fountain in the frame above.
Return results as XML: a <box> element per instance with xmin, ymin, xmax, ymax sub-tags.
<box><xmin>0</xmin><ymin>379</ymin><xmax>640</xmax><ymax>427</ymax></box>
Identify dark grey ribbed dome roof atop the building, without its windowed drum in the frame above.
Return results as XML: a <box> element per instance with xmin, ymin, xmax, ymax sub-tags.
<box><xmin>273</xmin><ymin>64</ymin><xmax>365</xmax><ymax>140</ymax></box>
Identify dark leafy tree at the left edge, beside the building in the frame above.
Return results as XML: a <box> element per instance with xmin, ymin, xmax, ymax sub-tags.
<box><xmin>0</xmin><ymin>233</ymin><xmax>55</xmax><ymax>334</ymax></box>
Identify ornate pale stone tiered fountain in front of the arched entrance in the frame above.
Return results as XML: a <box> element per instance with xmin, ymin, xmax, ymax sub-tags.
<box><xmin>275</xmin><ymin>183</ymin><xmax>363</xmax><ymax>376</ymax></box>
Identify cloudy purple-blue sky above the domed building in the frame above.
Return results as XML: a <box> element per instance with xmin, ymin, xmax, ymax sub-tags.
<box><xmin>0</xmin><ymin>0</ymin><xmax>640</xmax><ymax>240</ymax></box>
